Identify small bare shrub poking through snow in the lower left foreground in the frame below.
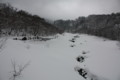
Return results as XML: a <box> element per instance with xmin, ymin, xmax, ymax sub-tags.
<box><xmin>10</xmin><ymin>60</ymin><xmax>30</xmax><ymax>80</ymax></box>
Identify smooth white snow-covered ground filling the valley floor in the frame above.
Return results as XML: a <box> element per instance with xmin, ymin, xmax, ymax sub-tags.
<box><xmin>0</xmin><ymin>33</ymin><xmax>120</xmax><ymax>80</ymax></box>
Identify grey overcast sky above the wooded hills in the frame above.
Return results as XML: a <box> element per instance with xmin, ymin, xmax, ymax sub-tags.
<box><xmin>0</xmin><ymin>0</ymin><xmax>120</xmax><ymax>20</ymax></box>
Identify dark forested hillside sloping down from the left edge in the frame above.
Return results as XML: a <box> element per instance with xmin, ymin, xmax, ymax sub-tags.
<box><xmin>0</xmin><ymin>3</ymin><xmax>62</xmax><ymax>36</ymax></box>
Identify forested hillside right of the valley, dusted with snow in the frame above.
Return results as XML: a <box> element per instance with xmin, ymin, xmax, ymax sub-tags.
<box><xmin>54</xmin><ymin>13</ymin><xmax>120</xmax><ymax>40</ymax></box>
